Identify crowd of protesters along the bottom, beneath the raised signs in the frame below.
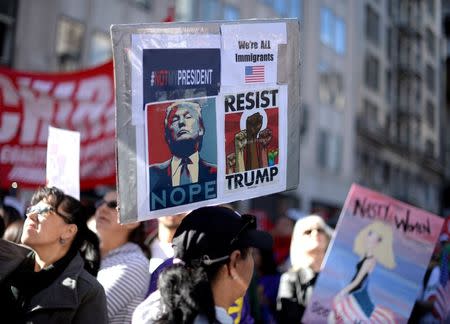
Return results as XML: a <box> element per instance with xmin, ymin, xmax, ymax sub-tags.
<box><xmin>0</xmin><ymin>187</ymin><xmax>450</xmax><ymax>324</ymax></box>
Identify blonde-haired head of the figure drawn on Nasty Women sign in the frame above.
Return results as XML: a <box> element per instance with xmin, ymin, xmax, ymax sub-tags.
<box><xmin>353</xmin><ymin>221</ymin><xmax>396</xmax><ymax>269</ymax></box>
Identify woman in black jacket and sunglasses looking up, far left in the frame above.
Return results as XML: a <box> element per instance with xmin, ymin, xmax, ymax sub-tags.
<box><xmin>0</xmin><ymin>187</ymin><xmax>107</xmax><ymax>324</ymax></box>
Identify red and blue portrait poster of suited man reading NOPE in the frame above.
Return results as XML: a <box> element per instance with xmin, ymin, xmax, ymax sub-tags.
<box><xmin>146</xmin><ymin>97</ymin><xmax>217</xmax><ymax>210</ymax></box>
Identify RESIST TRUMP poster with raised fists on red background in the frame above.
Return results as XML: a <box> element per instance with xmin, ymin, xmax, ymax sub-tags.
<box><xmin>219</xmin><ymin>86</ymin><xmax>287</xmax><ymax>199</ymax></box>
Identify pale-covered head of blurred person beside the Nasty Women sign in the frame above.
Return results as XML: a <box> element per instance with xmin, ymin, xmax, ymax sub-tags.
<box><xmin>290</xmin><ymin>215</ymin><xmax>333</xmax><ymax>269</ymax></box>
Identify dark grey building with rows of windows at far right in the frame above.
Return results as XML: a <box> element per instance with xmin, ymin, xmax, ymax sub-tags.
<box><xmin>355</xmin><ymin>0</ymin><xmax>444</xmax><ymax>213</ymax></box>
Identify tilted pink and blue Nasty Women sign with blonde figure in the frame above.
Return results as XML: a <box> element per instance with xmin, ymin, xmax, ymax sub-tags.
<box><xmin>303</xmin><ymin>185</ymin><xmax>443</xmax><ymax>323</ymax></box>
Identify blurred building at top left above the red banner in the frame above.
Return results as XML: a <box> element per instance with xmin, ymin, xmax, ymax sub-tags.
<box><xmin>0</xmin><ymin>0</ymin><xmax>172</xmax><ymax>72</ymax></box>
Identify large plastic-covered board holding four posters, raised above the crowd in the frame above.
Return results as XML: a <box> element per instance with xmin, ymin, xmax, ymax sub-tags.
<box><xmin>111</xmin><ymin>19</ymin><xmax>300</xmax><ymax>223</ymax></box>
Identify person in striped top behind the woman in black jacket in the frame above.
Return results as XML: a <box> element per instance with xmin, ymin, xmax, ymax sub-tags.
<box><xmin>95</xmin><ymin>191</ymin><xmax>150</xmax><ymax>323</ymax></box>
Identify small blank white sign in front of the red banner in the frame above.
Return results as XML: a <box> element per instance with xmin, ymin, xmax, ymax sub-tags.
<box><xmin>46</xmin><ymin>126</ymin><xmax>80</xmax><ymax>200</ymax></box>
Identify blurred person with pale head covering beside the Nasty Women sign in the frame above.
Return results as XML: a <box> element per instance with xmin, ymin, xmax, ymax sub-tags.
<box><xmin>277</xmin><ymin>215</ymin><xmax>333</xmax><ymax>323</ymax></box>
